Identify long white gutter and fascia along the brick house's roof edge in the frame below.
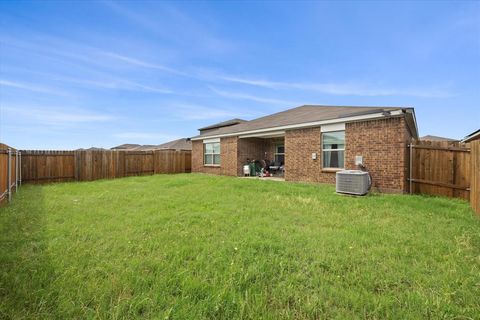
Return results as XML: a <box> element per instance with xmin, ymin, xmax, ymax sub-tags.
<box><xmin>191</xmin><ymin>109</ymin><xmax>404</xmax><ymax>141</ymax></box>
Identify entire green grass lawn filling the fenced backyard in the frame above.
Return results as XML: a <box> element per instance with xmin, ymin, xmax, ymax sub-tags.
<box><xmin>0</xmin><ymin>174</ymin><xmax>480</xmax><ymax>319</ymax></box>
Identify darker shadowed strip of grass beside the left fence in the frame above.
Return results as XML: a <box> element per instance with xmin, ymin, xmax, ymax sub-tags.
<box><xmin>0</xmin><ymin>185</ymin><xmax>58</xmax><ymax>319</ymax></box>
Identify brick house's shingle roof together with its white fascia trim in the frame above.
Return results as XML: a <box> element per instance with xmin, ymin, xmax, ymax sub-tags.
<box><xmin>192</xmin><ymin>105</ymin><xmax>418</xmax><ymax>140</ymax></box>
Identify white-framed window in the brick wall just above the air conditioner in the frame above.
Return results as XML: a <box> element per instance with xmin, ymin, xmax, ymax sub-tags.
<box><xmin>322</xmin><ymin>131</ymin><xmax>345</xmax><ymax>169</ymax></box>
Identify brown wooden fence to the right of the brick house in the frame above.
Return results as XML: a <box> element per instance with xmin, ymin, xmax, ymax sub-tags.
<box><xmin>408</xmin><ymin>141</ymin><xmax>480</xmax><ymax>214</ymax></box>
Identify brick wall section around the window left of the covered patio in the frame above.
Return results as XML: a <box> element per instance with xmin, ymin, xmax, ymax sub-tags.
<box><xmin>192</xmin><ymin>137</ymin><xmax>238</xmax><ymax>176</ymax></box>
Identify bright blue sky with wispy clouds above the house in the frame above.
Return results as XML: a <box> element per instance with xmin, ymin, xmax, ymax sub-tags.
<box><xmin>0</xmin><ymin>1</ymin><xmax>480</xmax><ymax>149</ymax></box>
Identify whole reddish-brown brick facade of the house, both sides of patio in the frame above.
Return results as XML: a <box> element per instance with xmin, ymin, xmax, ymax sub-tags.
<box><xmin>192</xmin><ymin>117</ymin><xmax>411</xmax><ymax>192</ymax></box>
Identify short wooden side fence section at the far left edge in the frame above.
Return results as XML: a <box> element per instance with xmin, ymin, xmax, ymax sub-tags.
<box><xmin>0</xmin><ymin>143</ymin><xmax>21</xmax><ymax>204</ymax></box>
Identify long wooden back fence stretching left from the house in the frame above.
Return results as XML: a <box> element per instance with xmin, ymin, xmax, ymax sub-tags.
<box><xmin>21</xmin><ymin>150</ymin><xmax>192</xmax><ymax>183</ymax></box>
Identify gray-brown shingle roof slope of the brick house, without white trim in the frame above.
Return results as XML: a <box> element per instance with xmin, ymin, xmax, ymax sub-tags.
<box><xmin>196</xmin><ymin>105</ymin><xmax>406</xmax><ymax>137</ymax></box>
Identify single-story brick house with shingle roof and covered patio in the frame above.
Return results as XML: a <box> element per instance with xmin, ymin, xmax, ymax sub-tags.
<box><xmin>192</xmin><ymin>105</ymin><xmax>418</xmax><ymax>192</ymax></box>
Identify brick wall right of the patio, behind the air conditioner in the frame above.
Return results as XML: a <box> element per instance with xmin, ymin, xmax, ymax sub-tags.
<box><xmin>285</xmin><ymin>118</ymin><xmax>410</xmax><ymax>192</ymax></box>
